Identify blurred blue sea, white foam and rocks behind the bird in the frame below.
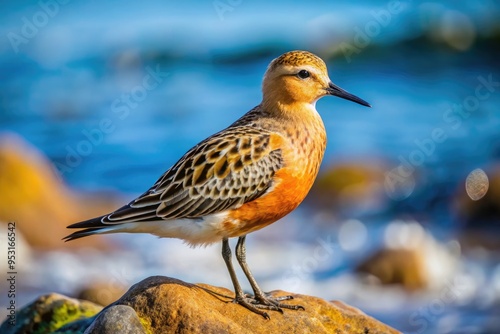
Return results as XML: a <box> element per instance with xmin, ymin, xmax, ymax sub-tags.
<box><xmin>0</xmin><ymin>0</ymin><xmax>500</xmax><ymax>333</ymax></box>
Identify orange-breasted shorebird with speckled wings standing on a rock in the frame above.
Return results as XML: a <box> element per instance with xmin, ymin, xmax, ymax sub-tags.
<box><xmin>64</xmin><ymin>50</ymin><xmax>371</xmax><ymax>319</ymax></box>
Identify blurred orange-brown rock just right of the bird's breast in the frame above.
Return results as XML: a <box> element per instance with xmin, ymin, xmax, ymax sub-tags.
<box><xmin>305</xmin><ymin>162</ymin><xmax>388</xmax><ymax>217</ymax></box>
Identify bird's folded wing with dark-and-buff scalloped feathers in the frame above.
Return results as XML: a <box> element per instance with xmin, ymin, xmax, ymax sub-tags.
<box><xmin>102</xmin><ymin>127</ymin><xmax>283</xmax><ymax>224</ymax></box>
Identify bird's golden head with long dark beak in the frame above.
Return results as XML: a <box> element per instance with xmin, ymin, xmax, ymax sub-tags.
<box><xmin>262</xmin><ymin>51</ymin><xmax>370</xmax><ymax>107</ymax></box>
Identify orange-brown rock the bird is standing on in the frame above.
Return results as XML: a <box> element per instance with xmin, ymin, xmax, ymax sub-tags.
<box><xmin>103</xmin><ymin>276</ymin><xmax>398</xmax><ymax>334</ymax></box>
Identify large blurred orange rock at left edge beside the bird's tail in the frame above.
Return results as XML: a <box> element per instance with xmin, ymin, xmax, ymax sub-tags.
<box><xmin>0</xmin><ymin>134</ymin><xmax>120</xmax><ymax>249</ymax></box>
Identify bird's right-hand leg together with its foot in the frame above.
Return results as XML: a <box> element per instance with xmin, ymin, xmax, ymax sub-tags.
<box><xmin>236</xmin><ymin>236</ymin><xmax>304</xmax><ymax>313</ymax></box>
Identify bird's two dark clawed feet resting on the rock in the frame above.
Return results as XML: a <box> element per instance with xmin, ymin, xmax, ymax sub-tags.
<box><xmin>234</xmin><ymin>294</ymin><xmax>304</xmax><ymax>319</ymax></box>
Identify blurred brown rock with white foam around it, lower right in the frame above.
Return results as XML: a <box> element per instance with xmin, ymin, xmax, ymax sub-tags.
<box><xmin>356</xmin><ymin>221</ymin><xmax>460</xmax><ymax>291</ymax></box>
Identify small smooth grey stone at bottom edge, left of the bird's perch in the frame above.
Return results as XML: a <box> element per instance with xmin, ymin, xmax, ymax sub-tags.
<box><xmin>85</xmin><ymin>305</ymin><xmax>146</xmax><ymax>334</ymax></box>
